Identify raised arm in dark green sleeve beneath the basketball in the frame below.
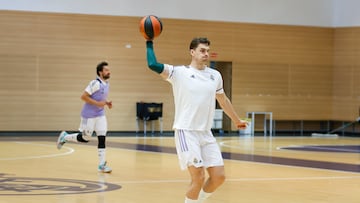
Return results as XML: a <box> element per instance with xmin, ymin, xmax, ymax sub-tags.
<box><xmin>146</xmin><ymin>41</ymin><xmax>169</xmax><ymax>79</ymax></box>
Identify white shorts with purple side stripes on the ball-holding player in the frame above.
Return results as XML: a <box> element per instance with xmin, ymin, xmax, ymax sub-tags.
<box><xmin>175</xmin><ymin>129</ymin><xmax>224</xmax><ymax>170</ymax></box>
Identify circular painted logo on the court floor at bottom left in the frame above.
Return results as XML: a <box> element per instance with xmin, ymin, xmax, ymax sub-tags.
<box><xmin>0</xmin><ymin>174</ymin><xmax>121</xmax><ymax>196</ymax></box>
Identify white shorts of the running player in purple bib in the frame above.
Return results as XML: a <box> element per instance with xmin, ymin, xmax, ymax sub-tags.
<box><xmin>79</xmin><ymin>116</ymin><xmax>107</xmax><ymax>136</ymax></box>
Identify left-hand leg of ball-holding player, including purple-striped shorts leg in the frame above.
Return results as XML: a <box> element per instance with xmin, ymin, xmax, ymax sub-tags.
<box><xmin>175</xmin><ymin>130</ymin><xmax>205</xmax><ymax>203</ymax></box>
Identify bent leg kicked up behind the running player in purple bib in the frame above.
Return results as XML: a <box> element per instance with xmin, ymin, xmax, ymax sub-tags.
<box><xmin>57</xmin><ymin>118</ymin><xmax>95</xmax><ymax>149</ymax></box>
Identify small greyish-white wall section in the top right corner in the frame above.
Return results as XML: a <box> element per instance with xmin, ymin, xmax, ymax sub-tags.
<box><xmin>333</xmin><ymin>0</ymin><xmax>360</xmax><ymax>27</ymax></box>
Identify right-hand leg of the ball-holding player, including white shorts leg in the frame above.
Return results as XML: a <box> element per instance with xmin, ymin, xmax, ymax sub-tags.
<box><xmin>199</xmin><ymin>132</ymin><xmax>225</xmax><ymax>203</ymax></box>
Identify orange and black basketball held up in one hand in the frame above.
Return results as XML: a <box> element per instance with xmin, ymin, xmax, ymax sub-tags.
<box><xmin>140</xmin><ymin>15</ymin><xmax>162</xmax><ymax>40</ymax></box>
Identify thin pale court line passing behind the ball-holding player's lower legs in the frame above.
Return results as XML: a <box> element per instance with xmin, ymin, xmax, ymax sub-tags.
<box><xmin>117</xmin><ymin>176</ymin><xmax>360</xmax><ymax>184</ymax></box>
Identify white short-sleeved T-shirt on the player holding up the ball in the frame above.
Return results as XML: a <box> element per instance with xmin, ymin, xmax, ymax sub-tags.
<box><xmin>165</xmin><ymin>64</ymin><xmax>224</xmax><ymax>131</ymax></box>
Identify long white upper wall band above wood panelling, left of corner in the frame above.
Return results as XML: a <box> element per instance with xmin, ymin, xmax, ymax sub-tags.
<box><xmin>0</xmin><ymin>0</ymin><xmax>334</xmax><ymax>27</ymax></box>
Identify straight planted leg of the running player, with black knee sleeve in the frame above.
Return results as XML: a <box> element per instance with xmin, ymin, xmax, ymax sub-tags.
<box><xmin>95</xmin><ymin>116</ymin><xmax>112</xmax><ymax>173</ymax></box>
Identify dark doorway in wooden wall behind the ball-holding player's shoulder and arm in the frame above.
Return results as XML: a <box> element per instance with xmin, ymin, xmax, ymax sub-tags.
<box><xmin>210</xmin><ymin>61</ymin><xmax>232</xmax><ymax>133</ymax></box>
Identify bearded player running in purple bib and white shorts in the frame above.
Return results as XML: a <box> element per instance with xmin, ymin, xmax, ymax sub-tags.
<box><xmin>57</xmin><ymin>62</ymin><xmax>112</xmax><ymax>173</ymax></box>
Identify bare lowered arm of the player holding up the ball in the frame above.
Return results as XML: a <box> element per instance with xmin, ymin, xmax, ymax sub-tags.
<box><xmin>216</xmin><ymin>93</ymin><xmax>248</xmax><ymax>129</ymax></box>
